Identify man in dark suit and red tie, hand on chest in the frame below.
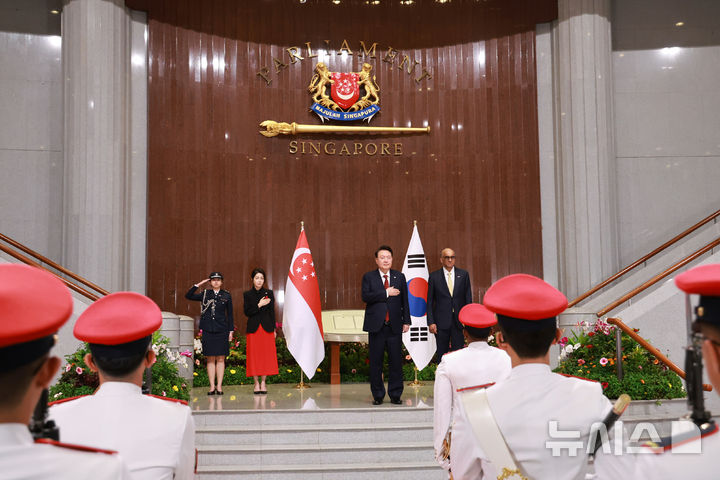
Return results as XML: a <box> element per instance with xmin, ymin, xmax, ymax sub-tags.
<box><xmin>362</xmin><ymin>245</ymin><xmax>410</xmax><ymax>405</ymax></box>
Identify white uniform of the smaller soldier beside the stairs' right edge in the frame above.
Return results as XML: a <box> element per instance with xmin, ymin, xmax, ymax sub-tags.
<box><xmin>433</xmin><ymin>341</ymin><xmax>512</xmax><ymax>480</ymax></box>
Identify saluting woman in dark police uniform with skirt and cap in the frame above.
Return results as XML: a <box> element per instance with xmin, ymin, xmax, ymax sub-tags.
<box><xmin>185</xmin><ymin>272</ymin><xmax>235</xmax><ymax>395</ymax></box>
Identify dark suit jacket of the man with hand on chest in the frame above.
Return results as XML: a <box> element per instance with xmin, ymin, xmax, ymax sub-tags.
<box><xmin>362</xmin><ymin>270</ymin><xmax>411</xmax><ymax>334</ymax></box>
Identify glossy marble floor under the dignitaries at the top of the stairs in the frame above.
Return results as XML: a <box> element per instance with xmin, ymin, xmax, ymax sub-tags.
<box><xmin>188</xmin><ymin>381</ymin><xmax>433</xmax><ymax>410</ymax></box>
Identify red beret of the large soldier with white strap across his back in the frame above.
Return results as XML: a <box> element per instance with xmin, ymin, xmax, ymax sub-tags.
<box><xmin>483</xmin><ymin>273</ymin><xmax>568</xmax><ymax>320</ymax></box>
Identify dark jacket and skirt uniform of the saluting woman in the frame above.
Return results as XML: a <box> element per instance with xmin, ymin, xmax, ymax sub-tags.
<box><xmin>185</xmin><ymin>285</ymin><xmax>235</xmax><ymax>356</ymax></box>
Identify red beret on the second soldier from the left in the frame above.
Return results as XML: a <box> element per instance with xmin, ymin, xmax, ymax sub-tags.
<box><xmin>73</xmin><ymin>292</ymin><xmax>162</xmax><ymax>345</ymax></box>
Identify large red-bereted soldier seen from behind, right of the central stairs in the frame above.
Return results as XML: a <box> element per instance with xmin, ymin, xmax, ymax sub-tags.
<box><xmin>470</xmin><ymin>274</ymin><xmax>635</xmax><ymax>480</ymax></box>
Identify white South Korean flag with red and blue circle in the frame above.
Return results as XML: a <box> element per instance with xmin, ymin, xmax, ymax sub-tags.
<box><xmin>403</xmin><ymin>225</ymin><xmax>436</xmax><ymax>370</ymax></box>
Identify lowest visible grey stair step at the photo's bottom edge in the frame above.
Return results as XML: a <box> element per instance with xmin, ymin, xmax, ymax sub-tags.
<box><xmin>197</xmin><ymin>461</ymin><xmax>447</xmax><ymax>480</ymax></box>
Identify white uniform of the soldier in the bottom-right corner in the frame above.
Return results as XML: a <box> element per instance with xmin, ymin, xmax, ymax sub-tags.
<box><xmin>640</xmin><ymin>431</ymin><xmax>720</xmax><ymax>480</ymax></box>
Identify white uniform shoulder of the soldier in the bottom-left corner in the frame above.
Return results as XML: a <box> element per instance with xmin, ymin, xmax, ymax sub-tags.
<box><xmin>0</xmin><ymin>423</ymin><xmax>132</xmax><ymax>480</ymax></box>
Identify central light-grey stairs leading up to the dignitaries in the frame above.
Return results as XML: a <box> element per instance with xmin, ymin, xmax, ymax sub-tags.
<box><xmin>193</xmin><ymin>405</ymin><xmax>447</xmax><ymax>480</ymax></box>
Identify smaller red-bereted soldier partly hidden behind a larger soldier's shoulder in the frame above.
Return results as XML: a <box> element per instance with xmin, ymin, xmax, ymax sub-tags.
<box><xmin>433</xmin><ymin>303</ymin><xmax>512</xmax><ymax>480</ymax></box>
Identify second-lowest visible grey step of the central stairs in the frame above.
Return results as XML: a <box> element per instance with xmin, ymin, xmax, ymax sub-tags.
<box><xmin>197</xmin><ymin>441</ymin><xmax>433</xmax><ymax>466</ymax></box>
